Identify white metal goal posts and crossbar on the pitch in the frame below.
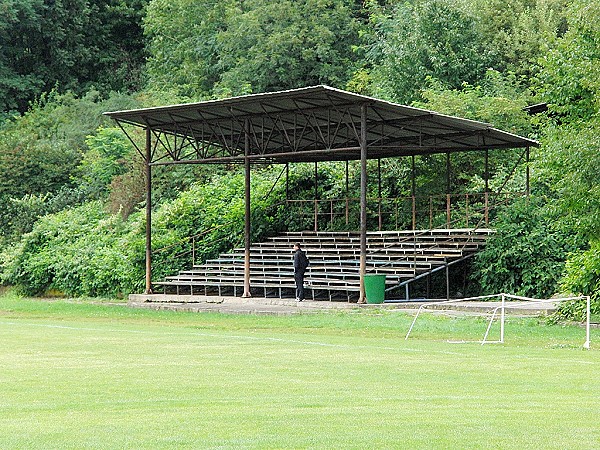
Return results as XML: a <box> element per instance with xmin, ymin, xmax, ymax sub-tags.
<box><xmin>404</xmin><ymin>293</ymin><xmax>591</xmax><ymax>349</ymax></box>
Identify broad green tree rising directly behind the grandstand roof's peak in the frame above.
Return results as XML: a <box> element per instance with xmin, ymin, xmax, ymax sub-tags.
<box><xmin>216</xmin><ymin>0</ymin><xmax>358</xmax><ymax>95</ymax></box>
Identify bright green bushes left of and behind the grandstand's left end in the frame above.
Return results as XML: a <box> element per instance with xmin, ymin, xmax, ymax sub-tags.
<box><xmin>0</xmin><ymin>170</ymin><xmax>283</xmax><ymax>297</ymax></box>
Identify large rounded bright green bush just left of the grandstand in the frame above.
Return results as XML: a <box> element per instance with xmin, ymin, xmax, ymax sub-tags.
<box><xmin>2</xmin><ymin>202</ymin><xmax>134</xmax><ymax>296</ymax></box>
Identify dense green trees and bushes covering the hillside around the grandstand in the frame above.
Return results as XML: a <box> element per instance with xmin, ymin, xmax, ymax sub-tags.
<box><xmin>0</xmin><ymin>0</ymin><xmax>600</xmax><ymax>314</ymax></box>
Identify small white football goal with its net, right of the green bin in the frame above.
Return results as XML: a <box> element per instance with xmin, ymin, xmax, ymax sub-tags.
<box><xmin>404</xmin><ymin>294</ymin><xmax>590</xmax><ymax>349</ymax></box>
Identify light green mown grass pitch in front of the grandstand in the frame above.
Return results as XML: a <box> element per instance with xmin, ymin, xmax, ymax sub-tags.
<box><xmin>0</xmin><ymin>294</ymin><xmax>600</xmax><ymax>449</ymax></box>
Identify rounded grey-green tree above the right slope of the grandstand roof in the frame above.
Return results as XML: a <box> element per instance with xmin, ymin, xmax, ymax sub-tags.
<box><xmin>369</xmin><ymin>0</ymin><xmax>490</xmax><ymax>104</ymax></box>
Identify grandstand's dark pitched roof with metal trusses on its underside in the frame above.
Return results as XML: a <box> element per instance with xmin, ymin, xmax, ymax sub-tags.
<box><xmin>105</xmin><ymin>86</ymin><xmax>539</xmax><ymax>165</ymax></box>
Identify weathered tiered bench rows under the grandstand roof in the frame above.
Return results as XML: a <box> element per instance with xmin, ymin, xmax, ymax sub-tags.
<box><xmin>155</xmin><ymin>228</ymin><xmax>492</xmax><ymax>301</ymax></box>
